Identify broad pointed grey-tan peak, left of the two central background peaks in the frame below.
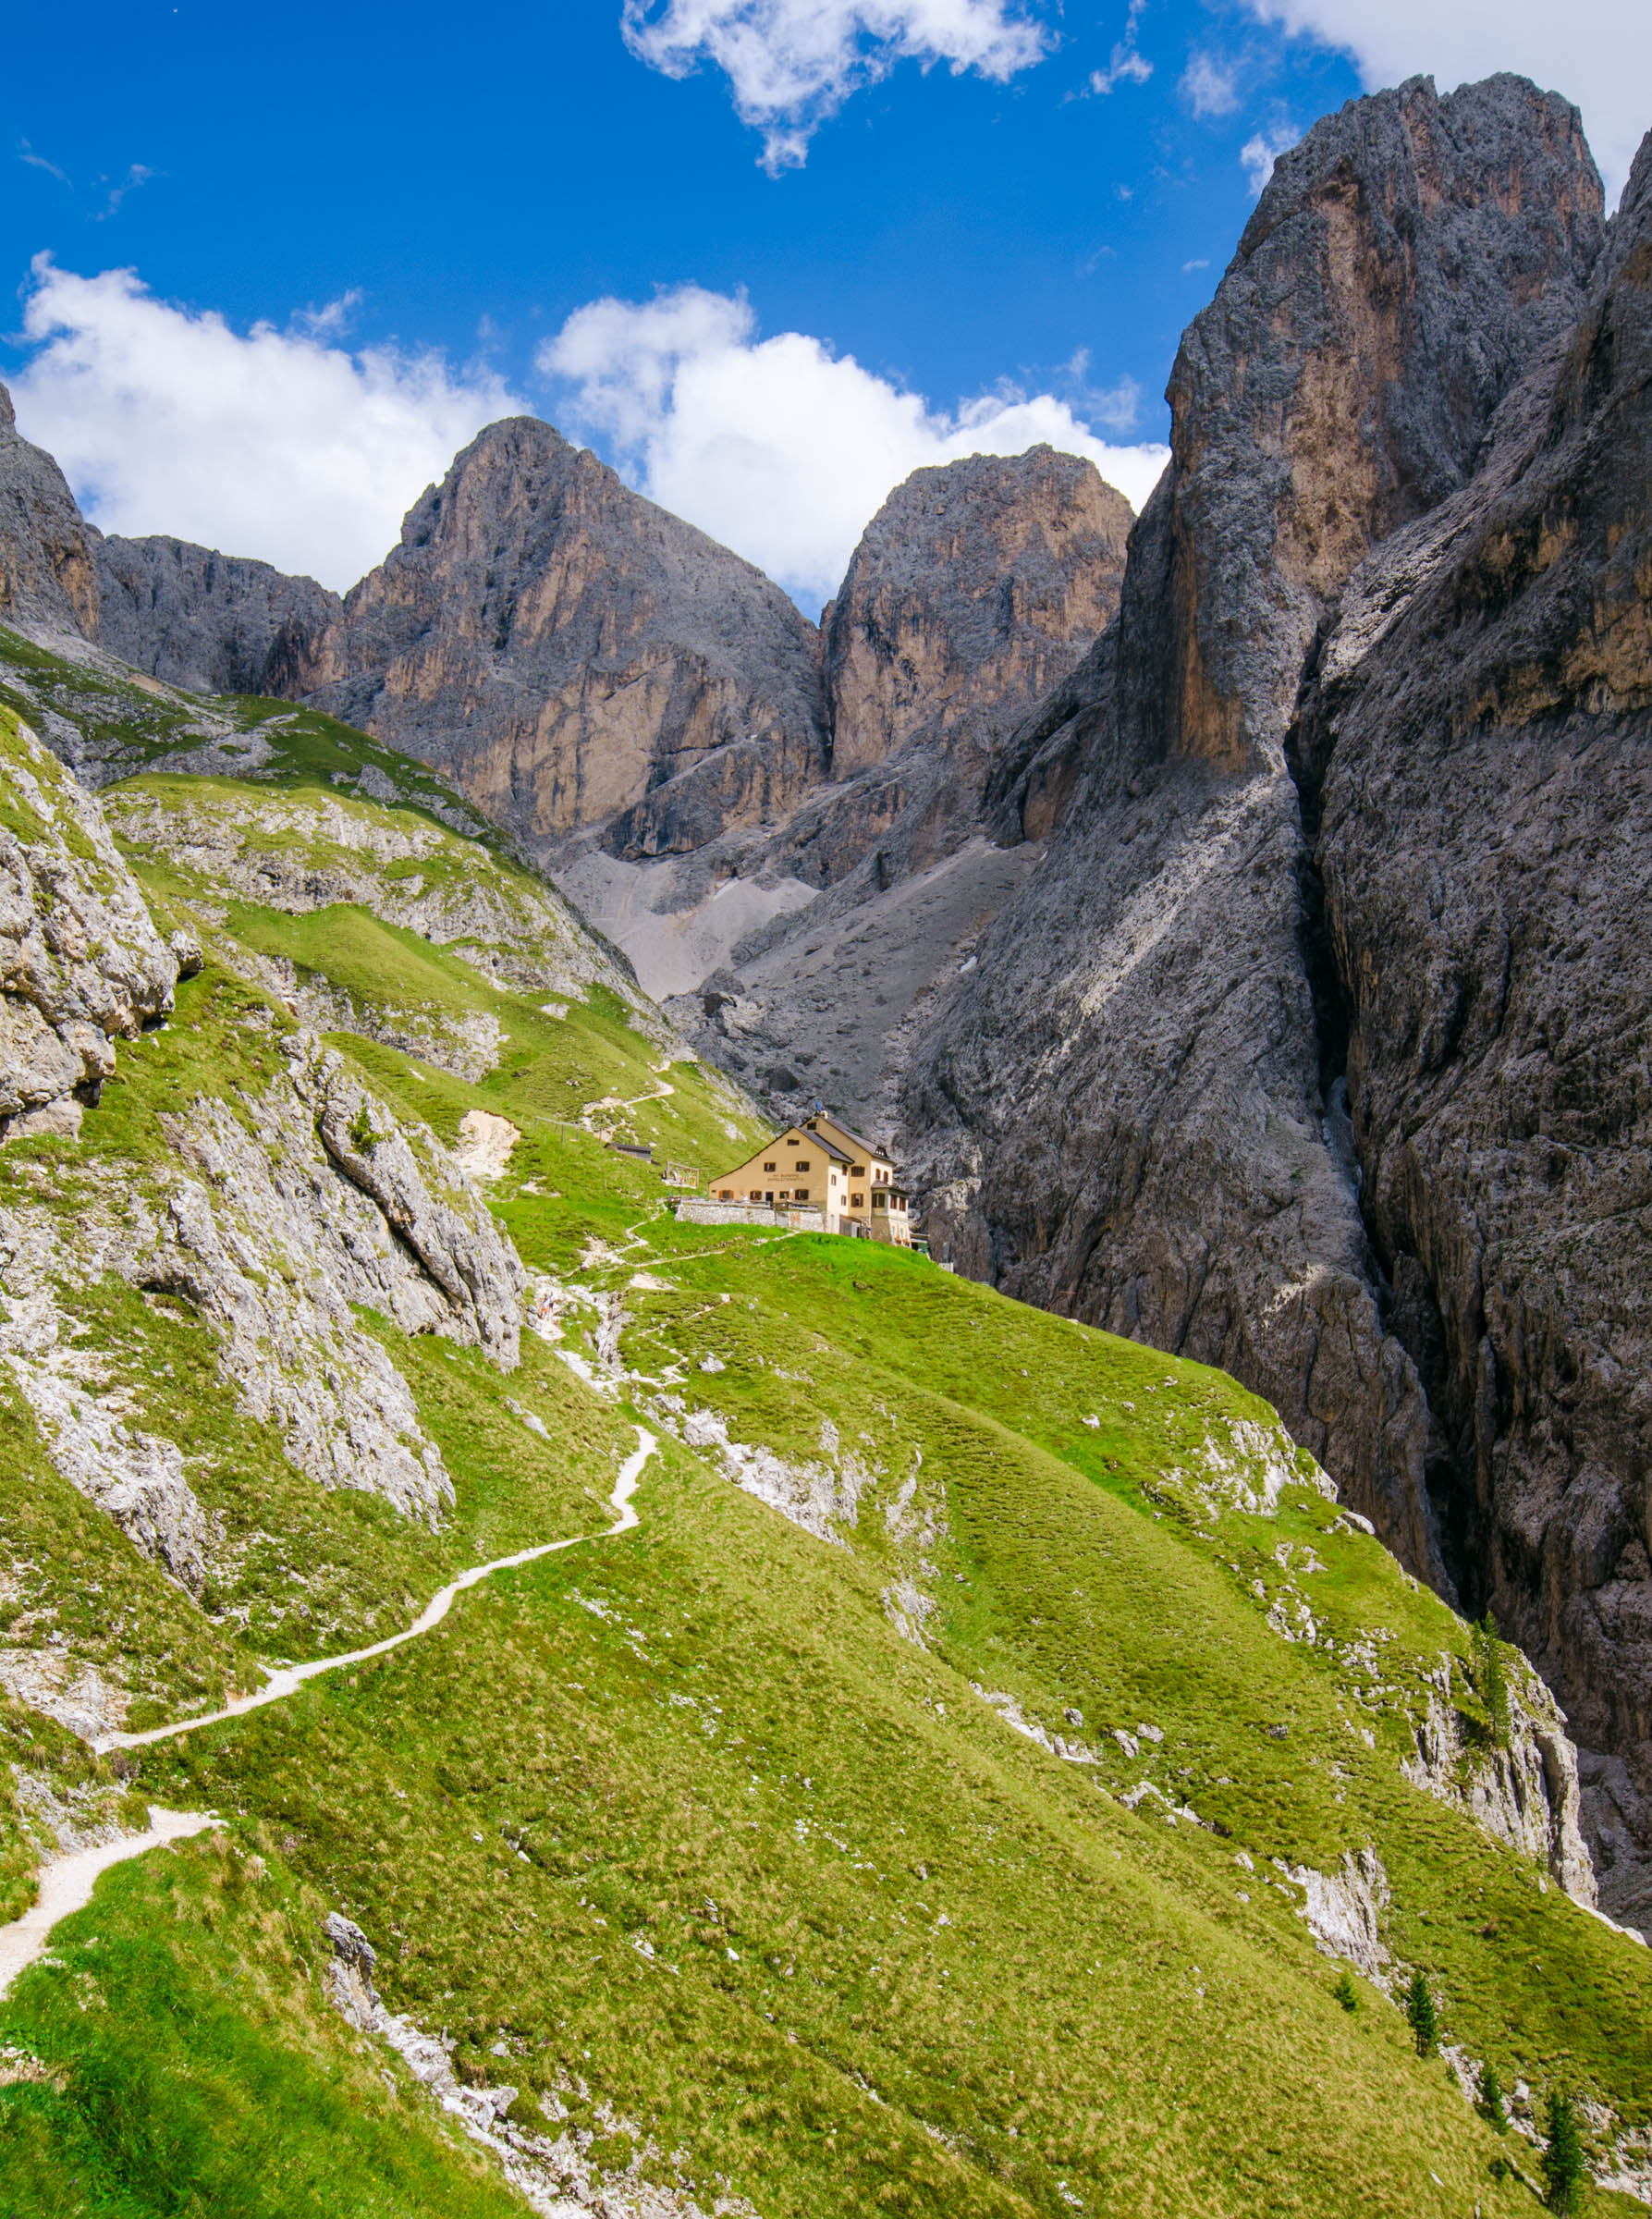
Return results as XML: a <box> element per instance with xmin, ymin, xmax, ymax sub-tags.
<box><xmin>284</xmin><ymin>417</ymin><xmax>825</xmax><ymax>856</ymax></box>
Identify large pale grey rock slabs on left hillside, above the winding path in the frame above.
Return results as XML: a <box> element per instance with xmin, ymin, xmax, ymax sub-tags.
<box><xmin>0</xmin><ymin>1032</ymin><xmax>525</xmax><ymax>1544</ymax></box>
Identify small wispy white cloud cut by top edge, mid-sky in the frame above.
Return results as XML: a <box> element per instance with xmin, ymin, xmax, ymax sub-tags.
<box><xmin>623</xmin><ymin>0</ymin><xmax>1051</xmax><ymax>171</ymax></box>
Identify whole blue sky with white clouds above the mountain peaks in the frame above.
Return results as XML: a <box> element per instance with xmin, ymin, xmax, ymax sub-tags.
<box><xmin>0</xmin><ymin>0</ymin><xmax>1652</xmax><ymax>606</ymax></box>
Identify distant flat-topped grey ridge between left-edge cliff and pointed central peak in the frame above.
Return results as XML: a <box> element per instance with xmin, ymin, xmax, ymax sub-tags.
<box><xmin>91</xmin><ymin>534</ymin><xmax>339</xmax><ymax>694</ymax></box>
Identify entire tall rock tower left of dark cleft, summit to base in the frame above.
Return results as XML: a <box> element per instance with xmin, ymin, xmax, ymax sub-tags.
<box><xmin>905</xmin><ymin>78</ymin><xmax>1601</xmax><ymax>1591</ymax></box>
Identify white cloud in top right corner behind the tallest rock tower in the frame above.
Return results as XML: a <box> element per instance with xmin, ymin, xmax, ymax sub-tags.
<box><xmin>1251</xmin><ymin>0</ymin><xmax>1652</xmax><ymax>198</ymax></box>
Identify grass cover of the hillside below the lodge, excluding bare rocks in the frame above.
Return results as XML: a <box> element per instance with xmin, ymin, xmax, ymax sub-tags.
<box><xmin>0</xmin><ymin>661</ymin><xmax>1652</xmax><ymax>2219</ymax></box>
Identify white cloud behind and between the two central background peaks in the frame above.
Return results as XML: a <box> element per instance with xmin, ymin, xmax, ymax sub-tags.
<box><xmin>539</xmin><ymin>287</ymin><xmax>1169</xmax><ymax>601</ymax></box>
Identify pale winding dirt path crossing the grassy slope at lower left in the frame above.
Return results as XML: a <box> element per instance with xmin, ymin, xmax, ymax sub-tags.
<box><xmin>0</xmin><ymin>1425</ymin><xmax>658</xmax><ymax>1995</ymax></box>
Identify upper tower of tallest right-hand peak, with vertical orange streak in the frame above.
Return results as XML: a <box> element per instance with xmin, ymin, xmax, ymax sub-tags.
<box><xmin>1118</xmin><ymin>78</ymin><xmax>1603</xmax><ymax>770</ymax></box>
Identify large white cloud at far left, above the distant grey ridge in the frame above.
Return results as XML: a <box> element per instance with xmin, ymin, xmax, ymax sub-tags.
<box><xmin>11</xmin><ymin>255</ymin><xmax>523</xmax><ymax>590</ymax></box>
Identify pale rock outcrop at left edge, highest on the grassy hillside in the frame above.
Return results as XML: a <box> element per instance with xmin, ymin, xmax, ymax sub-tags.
<box><xmin>0</xmin><ymin>705</ymin><xmax>177</xmax><ymax>1138</ymax></box>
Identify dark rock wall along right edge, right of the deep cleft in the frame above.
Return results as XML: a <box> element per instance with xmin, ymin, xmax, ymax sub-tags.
<box><xmin>1292</xmin><ymin>126</ymin><xmax>1652</xmax><ymax>1924</ymax></box>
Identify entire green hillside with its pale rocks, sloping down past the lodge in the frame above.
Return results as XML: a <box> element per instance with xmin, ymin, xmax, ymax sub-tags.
<box><xmin>0</xmin><ymin>634</ymin><xmax>1652</xmax><ymax>2219</ymax></box>
